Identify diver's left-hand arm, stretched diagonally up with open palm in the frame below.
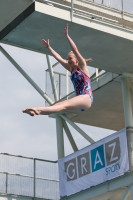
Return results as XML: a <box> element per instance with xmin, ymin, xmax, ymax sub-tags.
<box><xmin>42</xmin><ymin>39</ymin><xmax>70</xmax><ymax>71</ymax></box>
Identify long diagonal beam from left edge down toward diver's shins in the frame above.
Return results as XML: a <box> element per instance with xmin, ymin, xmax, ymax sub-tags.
<box><xmin>0</xmin><ymin>46</ymin><xmax>53</xmax><ymax>105</ymax></box>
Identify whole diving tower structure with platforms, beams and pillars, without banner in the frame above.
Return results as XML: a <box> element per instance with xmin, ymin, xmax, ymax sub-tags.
<box><xmin>0</xmin><ymin>0</ymin><xmax>133</xmax><ymax>200</ymax></box>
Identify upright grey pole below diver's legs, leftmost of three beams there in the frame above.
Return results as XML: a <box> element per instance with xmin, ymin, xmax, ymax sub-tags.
<box><xmin>56</xmin><ymin>116</ymin><xmax>64</xmax><ymax>159</ymax></box>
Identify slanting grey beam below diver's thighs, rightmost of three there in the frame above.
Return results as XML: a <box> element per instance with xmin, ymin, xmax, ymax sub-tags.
<box><xmin>60</xmin><ymin>115</ymin><xmax>95</xmax><ymax>144</ymax></box>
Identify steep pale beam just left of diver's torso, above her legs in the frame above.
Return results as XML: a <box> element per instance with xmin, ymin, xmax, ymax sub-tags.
<box><xmin>46</xmin><ymin>55</ymin><xmax>59</xmax><ymax>101</ymax></box>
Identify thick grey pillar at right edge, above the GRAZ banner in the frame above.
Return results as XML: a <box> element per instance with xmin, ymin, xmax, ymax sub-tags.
<box><xmin>121</xmin><ymin>77</ymin><xmax>133</xmax><ymax>127</ymax></box>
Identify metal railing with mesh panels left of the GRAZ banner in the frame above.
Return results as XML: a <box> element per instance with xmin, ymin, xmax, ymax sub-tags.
<box><xmin>0</xmin><ymin>153</ymin><xmax>60</xmax><ymax>200</ymax></box>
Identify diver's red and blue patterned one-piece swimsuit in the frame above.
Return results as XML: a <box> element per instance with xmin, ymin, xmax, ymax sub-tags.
<box><xmin>70</xmin><ymin>68</ymin><xmax>93</xmax><ymax>103</ymax></box>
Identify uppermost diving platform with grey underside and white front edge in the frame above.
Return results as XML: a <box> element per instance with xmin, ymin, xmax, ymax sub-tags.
<box><xmin>0</xmin><ymin>0</ymin><xmax>133</xmax><ymax>74</ymax></box>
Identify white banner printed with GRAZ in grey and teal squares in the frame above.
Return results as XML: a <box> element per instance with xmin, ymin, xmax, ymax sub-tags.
<box><xmin>58</xmin><ymin>129</ymin><xmax>129</xmax><ymax>197</ymax></box>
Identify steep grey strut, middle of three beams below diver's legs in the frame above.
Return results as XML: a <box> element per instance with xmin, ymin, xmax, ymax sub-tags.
<box><xmin>63</xmin><ymin>120</ymin><xmax>78</xmax><ymax>152</ymax></box>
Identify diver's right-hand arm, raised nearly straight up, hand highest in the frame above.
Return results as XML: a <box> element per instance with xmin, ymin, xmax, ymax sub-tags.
<box><xmin>65</xmin><ymin>24</ymin><xmax>86</xmax><ymax>68</ymax></box>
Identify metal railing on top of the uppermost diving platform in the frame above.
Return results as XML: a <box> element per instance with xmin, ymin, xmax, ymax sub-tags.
<box><xmin>36</xmin><ymin>0</ymin><xmax>133</xmax><ymax>30</ymax></box>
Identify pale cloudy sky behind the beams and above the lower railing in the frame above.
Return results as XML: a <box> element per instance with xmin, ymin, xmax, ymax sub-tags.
<box><xmin>0</xmin><ymin>44</ymin><xmax>114</xmax><ymax>160</ymax></box>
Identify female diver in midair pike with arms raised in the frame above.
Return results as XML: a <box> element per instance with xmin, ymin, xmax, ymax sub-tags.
<box><xmin>22</xmin><ymin>24</ymin><xmax>93</xmax><ymax>116</ymax></box>
